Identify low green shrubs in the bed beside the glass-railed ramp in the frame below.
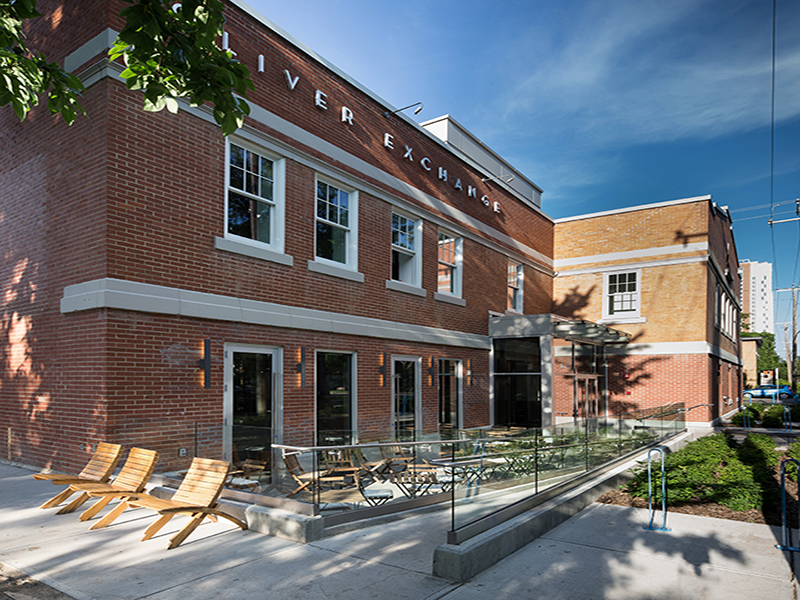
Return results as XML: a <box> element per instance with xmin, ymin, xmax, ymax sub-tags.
<box><xmin>625</xmin><ymin>433</ymin><xmax>776</xmax><ymax>510</ymax></box>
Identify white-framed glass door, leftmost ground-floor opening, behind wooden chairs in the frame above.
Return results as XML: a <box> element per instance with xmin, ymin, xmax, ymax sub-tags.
<box><xmin>223</xmin><ymin>347</ymin><xmax>280</xmax><ymax>483</ymax></box>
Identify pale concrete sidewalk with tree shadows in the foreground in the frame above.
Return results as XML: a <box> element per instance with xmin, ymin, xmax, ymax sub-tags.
<box><xmin>0</xmin><ymin>463</ymin><xmax>795</xmax><ymax>600</ymax></box>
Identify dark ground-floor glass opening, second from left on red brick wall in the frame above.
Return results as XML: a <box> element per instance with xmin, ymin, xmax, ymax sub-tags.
<box><xmin>317</xmin><ymin>352</ymin><xmax>353</xmax><ymax>446</ymax></box>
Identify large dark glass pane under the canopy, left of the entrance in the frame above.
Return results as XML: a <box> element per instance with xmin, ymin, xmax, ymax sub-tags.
<box><xmin>494</xmin><ymin>338</ymin><xmax>542</xmax><ymax>428</ymax></box>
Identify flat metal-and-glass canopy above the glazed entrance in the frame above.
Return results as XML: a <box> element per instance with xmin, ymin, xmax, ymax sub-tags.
<box><xmin>489</xmin><ymin>314</ymin><xmax>629</xmax><ymax>346</ymax></box>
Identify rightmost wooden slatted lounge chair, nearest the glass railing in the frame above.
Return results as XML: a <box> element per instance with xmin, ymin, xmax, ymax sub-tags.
<box><xmin>90</xmin><ymin>458</ymin><xmax>247</xmax><ymax>550</ymax></box>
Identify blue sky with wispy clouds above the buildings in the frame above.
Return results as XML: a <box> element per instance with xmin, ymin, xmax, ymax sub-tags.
<box><xmin>245</xmin><ymin>0</ymin><xmax>800</xmax><ymax>342</ymax></box>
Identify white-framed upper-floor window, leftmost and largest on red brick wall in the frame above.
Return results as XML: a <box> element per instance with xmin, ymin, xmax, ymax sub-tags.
<box><xmin>225</xmin><ymin>140</ymin><xmax>284</xmax><ymax>252</ymax></box>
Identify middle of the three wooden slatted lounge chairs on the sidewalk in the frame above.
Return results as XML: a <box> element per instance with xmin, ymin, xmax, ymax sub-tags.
<box><xmin>56</xmin><ymin>448</ymin><xmax>158</xmax><ymax>521</ymax></box>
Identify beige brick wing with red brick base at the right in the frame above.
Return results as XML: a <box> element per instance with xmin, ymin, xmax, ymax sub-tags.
<box><xmin>553</xmin><ymin>196</ymin><xmax>742</xmax><ymax>423</ymax></box>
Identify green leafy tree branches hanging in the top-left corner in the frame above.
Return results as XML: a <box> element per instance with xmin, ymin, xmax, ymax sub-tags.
<box><xmin>0</xmin><ymin>0</ymin><xmax>253</xmax><ymax>135</ymax></box>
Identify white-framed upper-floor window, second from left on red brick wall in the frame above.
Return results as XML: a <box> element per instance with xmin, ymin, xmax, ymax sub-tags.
<box><xmin>314</xmin><ymin>179</ymin><xmax>358</xmax><ymax>270</ymax></box>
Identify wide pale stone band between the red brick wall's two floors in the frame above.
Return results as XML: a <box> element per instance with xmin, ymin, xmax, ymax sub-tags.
<box><xmin>61</xmin><ymin>278</ymin><xmax>492</xmax><ymax>350</ymax></box>
